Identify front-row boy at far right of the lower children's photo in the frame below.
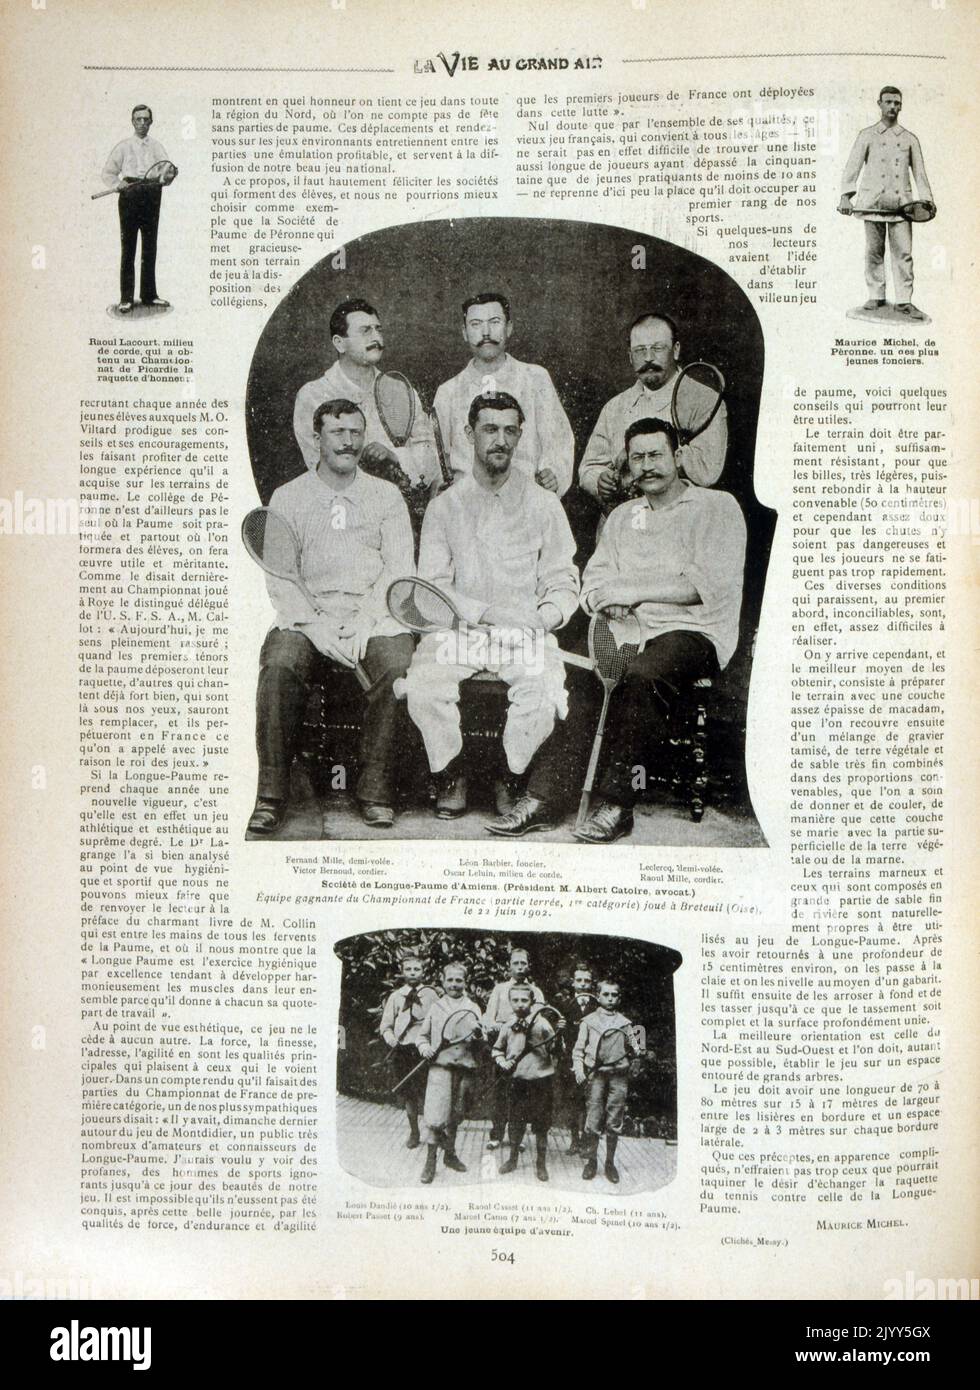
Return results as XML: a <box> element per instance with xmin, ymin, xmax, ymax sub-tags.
<box><xmin>571</xmin><ymin>980</ymin><xmax>642</xmax><ymax>1183</ymax></box>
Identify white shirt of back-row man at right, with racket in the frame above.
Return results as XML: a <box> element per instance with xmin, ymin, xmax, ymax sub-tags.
<box><xmin>578</xmin><ymin>373</ymin><xmax>728</xmax><ymax>498</ymax></box>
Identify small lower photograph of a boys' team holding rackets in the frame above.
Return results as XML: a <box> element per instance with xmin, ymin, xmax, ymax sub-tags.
<box><xmin>335</xmin><ymin>930</ymin><xmax>680</xmax><ymax>1191</ymax></box>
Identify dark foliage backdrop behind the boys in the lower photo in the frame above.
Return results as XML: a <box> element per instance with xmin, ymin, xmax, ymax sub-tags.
<box><xmin>334</xmin><ymin>929</ymin><xmax>681</xmax><ymax>1140</ymax></box>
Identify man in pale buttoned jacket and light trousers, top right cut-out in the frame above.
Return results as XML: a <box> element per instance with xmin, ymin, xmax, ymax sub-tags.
<box><xmin>837</xmin><ymin>86</ymin><xmax>936</xmax><ymax>320</ymax></box>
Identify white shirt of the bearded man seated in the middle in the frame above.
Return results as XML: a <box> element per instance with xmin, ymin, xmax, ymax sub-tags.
<box><xmin>418</xmin><ymin>471</ymin><xmax>578</xmax><ymax>627</ymax></box>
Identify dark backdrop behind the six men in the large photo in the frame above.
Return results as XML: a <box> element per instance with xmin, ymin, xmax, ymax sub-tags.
<box><xmin>246</xmin><ymin>218</ymin><xmax>776</xmax><ymax>816</ymax></box>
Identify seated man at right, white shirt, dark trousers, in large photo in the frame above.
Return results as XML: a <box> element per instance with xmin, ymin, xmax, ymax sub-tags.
<box><xmin>488</xmin><ymin>418</ymin><xmax>745</xmax><ymax>844</ymax></box>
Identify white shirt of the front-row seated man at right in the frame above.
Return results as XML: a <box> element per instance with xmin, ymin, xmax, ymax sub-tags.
<box><xmin>582</xmin><ymin>484</ymin><xmax>745</xmax><ymax>670</ymax></box>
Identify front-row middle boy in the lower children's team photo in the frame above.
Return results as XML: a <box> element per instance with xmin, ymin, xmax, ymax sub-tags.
<box><xmin>493</xmin><ymin>984</ymin><xmax>557</xmax><ymax>1183</ymax></box>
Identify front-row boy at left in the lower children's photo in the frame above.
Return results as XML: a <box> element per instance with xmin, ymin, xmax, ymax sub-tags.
<box><xmin>416</xmin><ymin>962</ymin><xmax>482</xmax><ymax>1183</ymax></box>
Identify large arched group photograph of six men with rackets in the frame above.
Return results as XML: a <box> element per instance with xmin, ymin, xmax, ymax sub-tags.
<box><xmin>242</xmin><ymin>218</ymin><xmax>774</xmax><ymax>847</ymax></box>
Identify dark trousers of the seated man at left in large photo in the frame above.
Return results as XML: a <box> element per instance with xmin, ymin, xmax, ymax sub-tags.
<box><xmin>256</xmin><ymin>627</ymin><xmax>414</xmax><ymax>805</ymax></box>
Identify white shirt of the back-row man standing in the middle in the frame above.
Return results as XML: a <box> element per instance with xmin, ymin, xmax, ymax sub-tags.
<box><xmin>434</xmin><ymin>356</ymin><xmax>575</xmax><ymax>496</ymax></box>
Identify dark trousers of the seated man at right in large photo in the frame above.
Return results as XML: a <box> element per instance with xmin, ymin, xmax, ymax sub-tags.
<box><xmin>527</xmin><ymin>631</ymin><xmax>719</xmax><ymax>806</ymax></box>
